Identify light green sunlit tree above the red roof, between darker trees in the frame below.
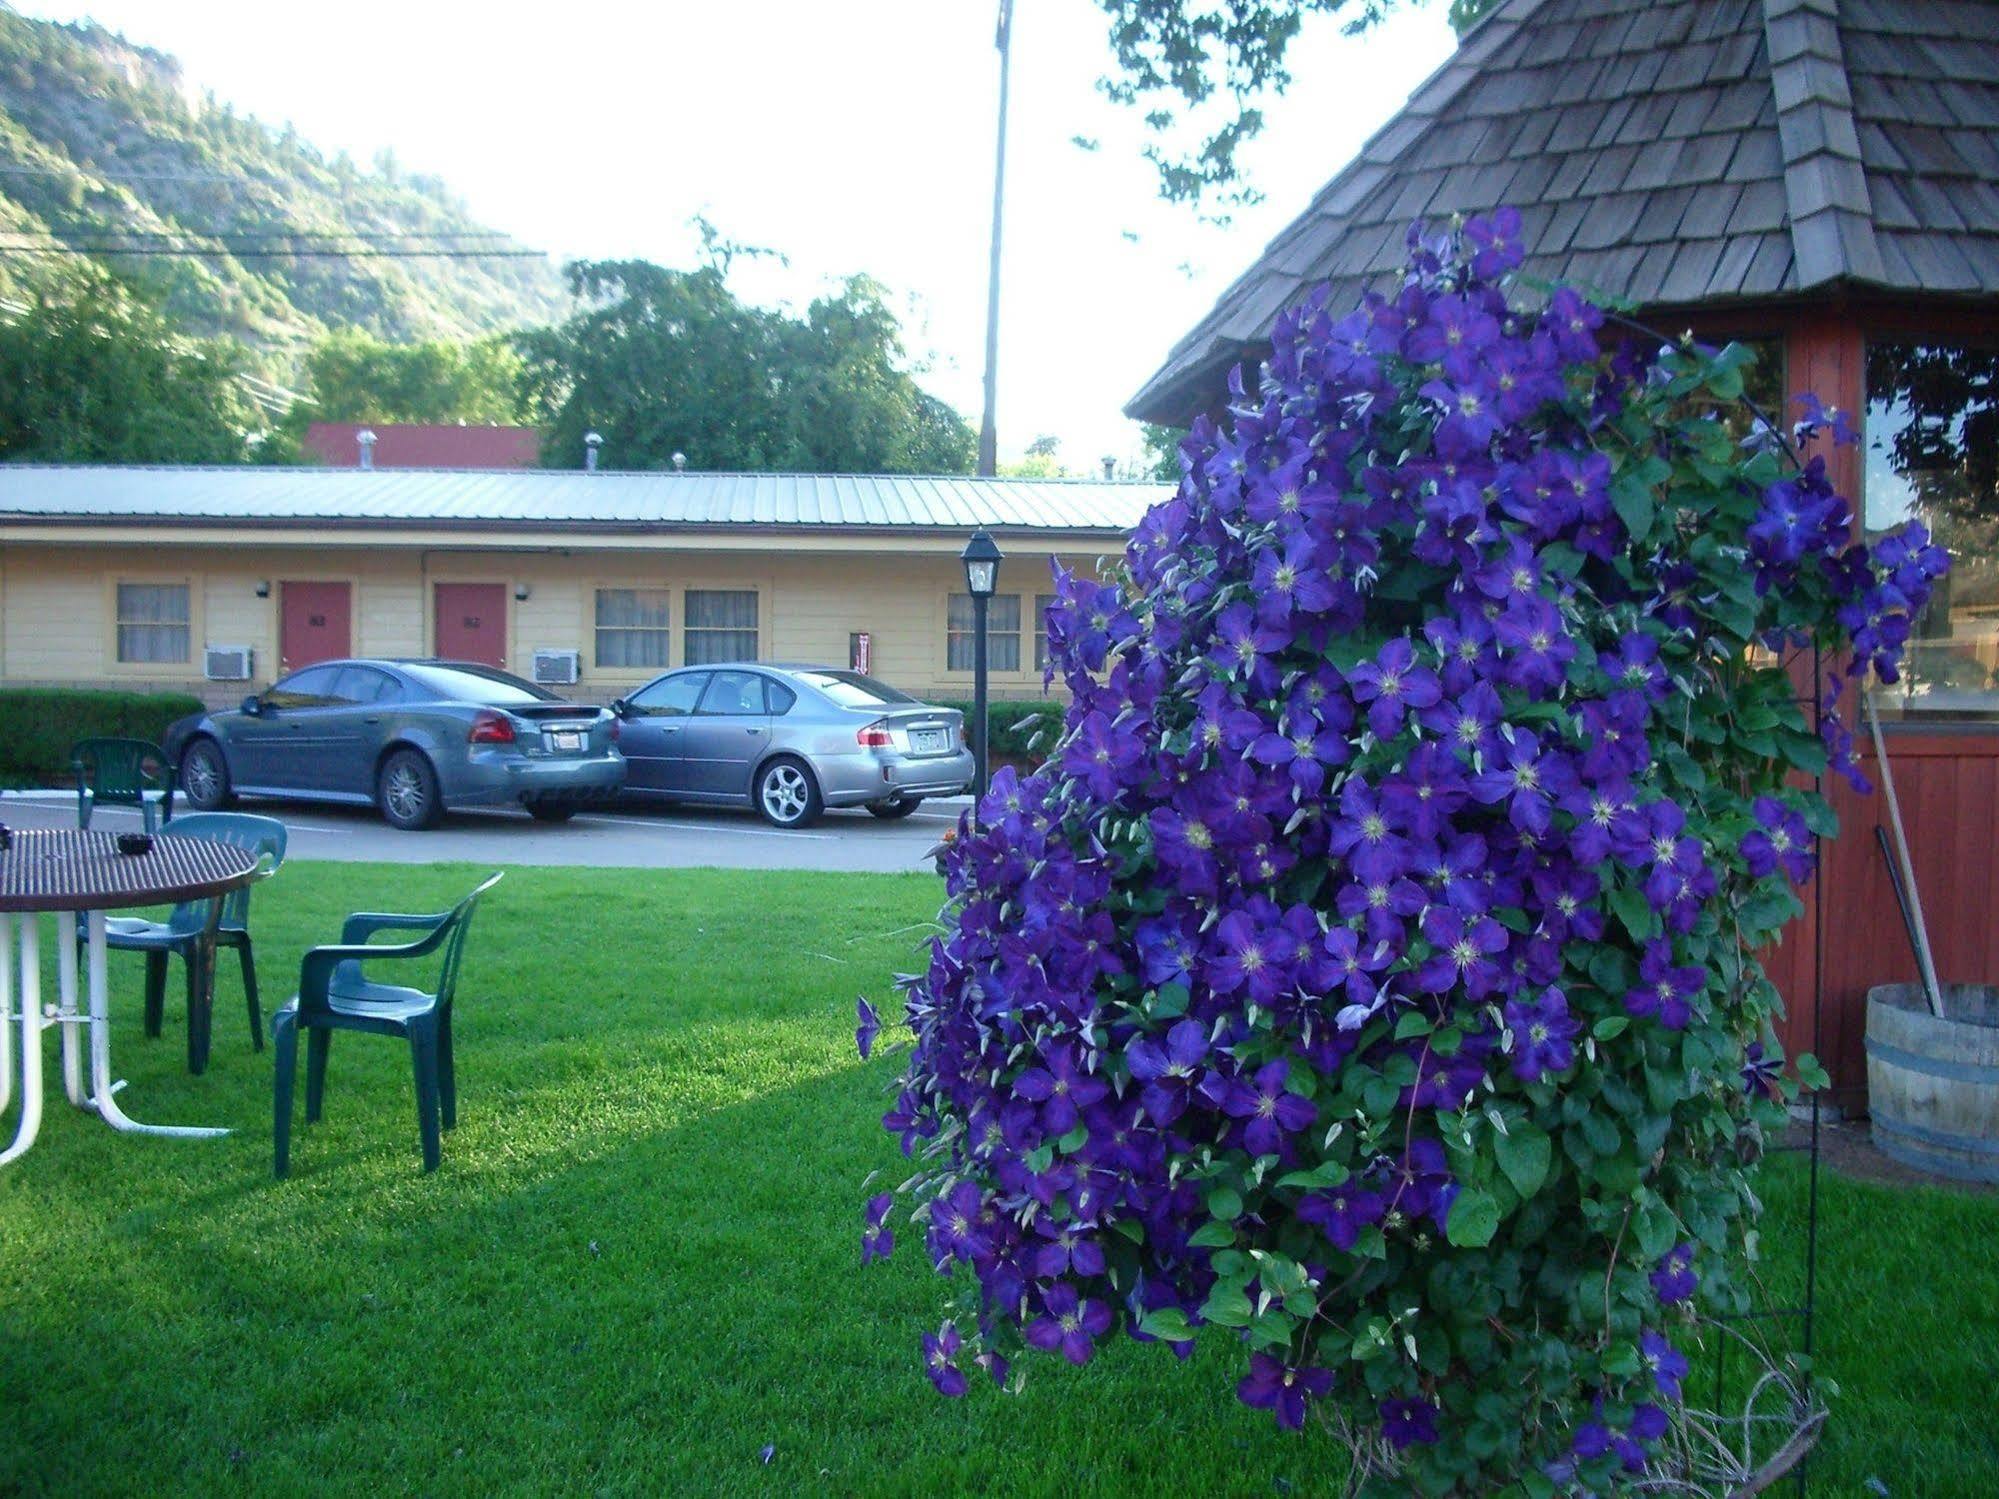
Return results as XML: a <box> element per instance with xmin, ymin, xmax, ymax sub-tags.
<box><xmin>298</xmin><ymin>328</ymin><xmax>524</xmax><ymax>426</ymax></box>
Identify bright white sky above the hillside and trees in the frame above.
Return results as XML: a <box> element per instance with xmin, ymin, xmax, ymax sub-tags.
<box><xmin>16</xmin><ymin>0</ymin><xmax>1453</xmax><ymax>472</ymax></box>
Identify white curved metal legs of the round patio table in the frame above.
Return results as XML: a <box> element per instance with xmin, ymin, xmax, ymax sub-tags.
<box><xmin>0</xmin><ymin>911</ymin><xmax>230</xmax><ymax>1165</ymax></box>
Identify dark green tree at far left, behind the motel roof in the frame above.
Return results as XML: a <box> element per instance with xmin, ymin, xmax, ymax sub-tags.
<box><xmin>0</xmin><ymin>262</ymin><xmax>266</xmax><ymax>464</ymax></box>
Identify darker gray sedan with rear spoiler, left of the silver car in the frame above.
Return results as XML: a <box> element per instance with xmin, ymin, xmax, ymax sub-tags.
<box><xmin>166</xmin><ymin>660</ymin><xmax>626</xmax><ymax>827</ymax></box>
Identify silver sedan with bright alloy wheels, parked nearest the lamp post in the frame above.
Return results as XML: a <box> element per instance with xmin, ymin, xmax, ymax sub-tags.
<box><xmin>612</xmin><ymin>662</ymin><xmax>974</xmax><ymax>827</ymax></box>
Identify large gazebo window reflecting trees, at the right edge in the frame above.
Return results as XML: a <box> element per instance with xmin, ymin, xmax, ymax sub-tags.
<box><xmin>1861</xmin><ymin>342</ymin><xmax>1999</xmax><ymax>722</ymax></box>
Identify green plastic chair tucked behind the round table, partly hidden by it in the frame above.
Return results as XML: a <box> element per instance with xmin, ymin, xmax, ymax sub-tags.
<box><xmin>93</xmin><ymin>811</ymin><xmax>288</xmax><ymax>1075</ymax></box>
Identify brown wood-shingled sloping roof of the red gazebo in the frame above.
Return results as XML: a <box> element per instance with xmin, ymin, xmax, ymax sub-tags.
<box><xmin>1125</xmin><ymin>0</ymin><xmax>1999</xmax><ymax>422</ymax></box>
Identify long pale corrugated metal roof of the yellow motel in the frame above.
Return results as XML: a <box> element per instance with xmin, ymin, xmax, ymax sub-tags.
<box><xmin>0</xmin><ymin>464</ymin><xmax>1171</xmax><ymax>532</ymax></box>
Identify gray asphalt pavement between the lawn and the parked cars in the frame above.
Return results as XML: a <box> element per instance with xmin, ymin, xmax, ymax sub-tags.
<box><xmin>0</xmin><ymin>791</ymin><xmax>968</xmax><ymax>873</ymax></box>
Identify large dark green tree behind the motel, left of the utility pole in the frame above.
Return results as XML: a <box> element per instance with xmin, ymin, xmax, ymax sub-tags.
<box><xmin>518</xmin><ymin>252</ymin><xmax>976</xmax><ymax>474</ymax></box>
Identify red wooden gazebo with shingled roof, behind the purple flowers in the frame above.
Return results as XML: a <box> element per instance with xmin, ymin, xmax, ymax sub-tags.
<box><xmin>1125</xmin><ymin>0</ymin><xmax>1999</xmax><ymax>1107</ymax></box>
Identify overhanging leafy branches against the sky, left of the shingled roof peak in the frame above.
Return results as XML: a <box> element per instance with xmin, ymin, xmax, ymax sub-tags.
<box><xmin>1097</xmin><ymin>0</ymin><xmax>1497</xmax><ymax>208</ymax></box>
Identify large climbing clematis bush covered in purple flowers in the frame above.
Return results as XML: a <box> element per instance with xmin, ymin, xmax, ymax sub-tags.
<box><xmin>860</xmin><ymin>212</ymin><xmax>1945</xmax><ymax>1495</ymax></box>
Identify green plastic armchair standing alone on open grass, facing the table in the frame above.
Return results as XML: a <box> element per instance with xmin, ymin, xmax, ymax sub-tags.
<box><xmin>270</xmin><ymin>873</ymin><xmax>504</xmax><ymax>1177</ymax></box>
